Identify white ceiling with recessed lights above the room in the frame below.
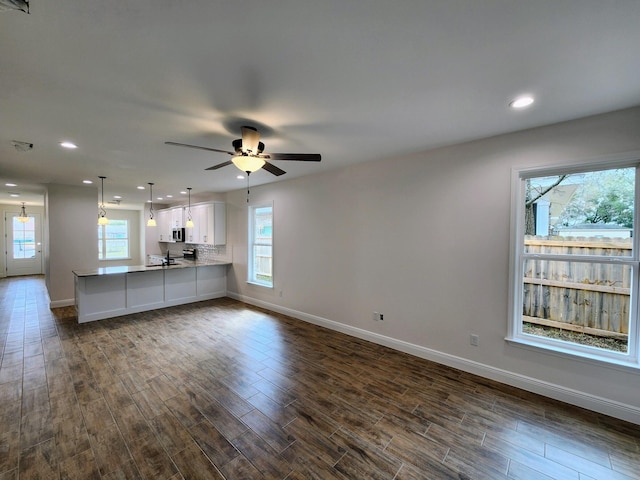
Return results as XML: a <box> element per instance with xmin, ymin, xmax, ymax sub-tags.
<box><xmin>0</xmin><ymin>0</ymin><xmax>640</xmax><ymax>207</ymax></box>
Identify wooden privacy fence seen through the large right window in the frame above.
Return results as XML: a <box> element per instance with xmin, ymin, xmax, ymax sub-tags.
<box><xmin>523</xmin><ymin>236</ymin><xmax>632</xmax><ymax>339</ymax></box>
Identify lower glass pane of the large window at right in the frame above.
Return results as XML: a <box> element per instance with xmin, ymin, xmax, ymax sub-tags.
<box><xmin>522</xmin><ymin>258</ymin><xmax>632</xmax><ymax>352</ymax></box>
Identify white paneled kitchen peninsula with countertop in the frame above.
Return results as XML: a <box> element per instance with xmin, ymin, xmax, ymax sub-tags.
<box><xmin>73</xmin><ymin>260</ymin><xmax>231</xmax><ymax>323</ymax></box>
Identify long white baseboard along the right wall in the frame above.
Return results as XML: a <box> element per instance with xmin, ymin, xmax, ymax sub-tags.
<box><xmin>227</xmin><ymin>292</ymin><xmax>640</xmax><ymax>425</ymax></box>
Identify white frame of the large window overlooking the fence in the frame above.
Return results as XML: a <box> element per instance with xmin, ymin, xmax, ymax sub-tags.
<box><xmin>505</xmin><ymin>157</ymin><xmax>640</xmax><ymax>370</ymax></box>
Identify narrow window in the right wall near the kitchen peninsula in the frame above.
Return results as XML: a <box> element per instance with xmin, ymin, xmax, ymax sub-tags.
<box><xmin>248</xmin><ymin>205</ymin><xmax>273</xmax><ymax>287</ymax></box>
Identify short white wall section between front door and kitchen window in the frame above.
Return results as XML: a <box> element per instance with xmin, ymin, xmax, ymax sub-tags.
<box><xmin>45</xmin><ymin>184</ymin><xmax>98</xmax><ymax>307</ymax></box>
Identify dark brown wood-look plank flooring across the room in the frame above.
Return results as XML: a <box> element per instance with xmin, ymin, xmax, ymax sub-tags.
<box><xmin>0</xmin><ymin>277</ymin><xmax>640</xmax><ymax>480</ymax></box>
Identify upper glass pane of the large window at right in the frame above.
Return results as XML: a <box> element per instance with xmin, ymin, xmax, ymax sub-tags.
<box><xmin>524</xmin><ymin>167</ymin><xmax>635</xmax><ymax>257</ymax></box>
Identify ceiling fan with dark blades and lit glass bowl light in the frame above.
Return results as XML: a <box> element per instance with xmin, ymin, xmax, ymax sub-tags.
<box><xmin>164</xmin><ymin>127</ymin><xmax>321</xmax><ymax>176</ymax></box>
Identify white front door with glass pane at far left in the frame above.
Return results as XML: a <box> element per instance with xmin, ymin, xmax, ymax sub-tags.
<box><xmin>4</xmin><ymin>212</ymin><xmax>42</xmax><ymax>277</ymax></box>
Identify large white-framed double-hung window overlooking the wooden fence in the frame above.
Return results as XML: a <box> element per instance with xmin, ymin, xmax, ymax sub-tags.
<box><xmin>509</xmin><ymin>165</ymin><xmax>639</xmax><ymax>366</ymax></box>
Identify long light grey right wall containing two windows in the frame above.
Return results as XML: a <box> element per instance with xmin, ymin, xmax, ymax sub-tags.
<box><xmin>227</xmin><ymin>108</ymin><xmax>640</xmax><ymax>423</ymax></box>
